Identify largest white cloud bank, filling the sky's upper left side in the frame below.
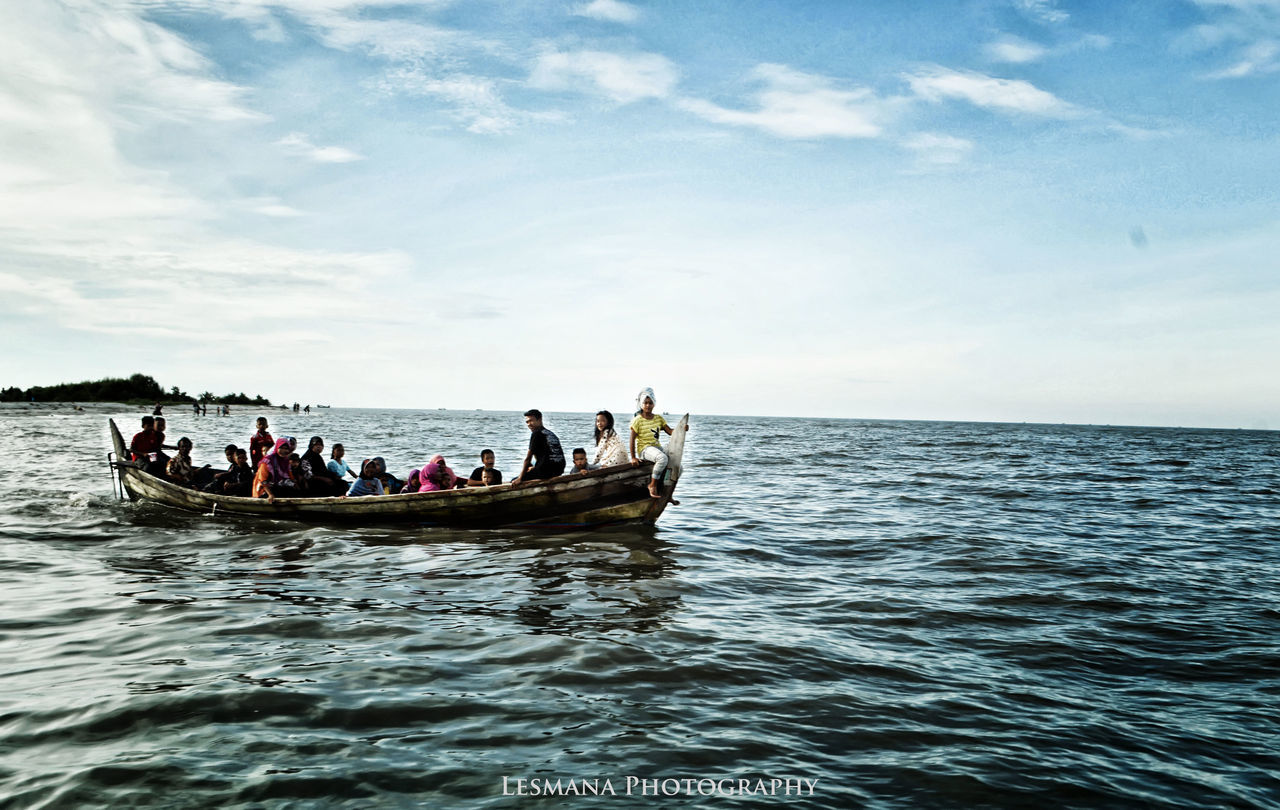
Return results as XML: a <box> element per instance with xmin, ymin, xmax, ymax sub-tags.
<box><xmin>0</xmin><ymin>1</ymin><xmax>419</xmax><ymax>348</ymax></box>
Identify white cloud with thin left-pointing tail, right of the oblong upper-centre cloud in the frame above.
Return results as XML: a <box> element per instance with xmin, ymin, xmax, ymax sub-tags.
<box><xmin>678</xmin><ymin>64</ymin><xmax>890</xmax><ymax>138</ymax></box>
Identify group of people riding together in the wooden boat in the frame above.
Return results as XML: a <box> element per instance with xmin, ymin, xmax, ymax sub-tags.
<box><xmin>129</xmin><ymin>388</ymin><xmax>672</xmax><ymax>503</ymax></box>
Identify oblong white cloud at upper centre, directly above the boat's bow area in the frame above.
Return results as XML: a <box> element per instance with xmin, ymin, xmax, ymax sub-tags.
<box><xmin>529</xmin><ymin>51</ymin><xmax>678</xmax><ymax>104</ymax></box>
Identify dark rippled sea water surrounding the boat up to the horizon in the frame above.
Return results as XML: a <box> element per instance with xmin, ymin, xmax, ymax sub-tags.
<box><xmin>0</xmin><ymin>407</ymin><xmax>1280</xmax><ymax>810</ymax></box>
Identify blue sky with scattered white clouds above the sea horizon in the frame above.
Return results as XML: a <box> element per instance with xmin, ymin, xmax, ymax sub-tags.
<box><xmin>0</xmin><ymin>0</ymin><xmax>1280</xmax><ymax>429</ymax></box>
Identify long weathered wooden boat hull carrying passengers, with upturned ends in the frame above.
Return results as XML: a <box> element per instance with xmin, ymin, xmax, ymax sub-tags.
<box><xmin>108</xmin><ymin>413</ymin><xmax>689</xmax><ymax>528</ymax></box>
